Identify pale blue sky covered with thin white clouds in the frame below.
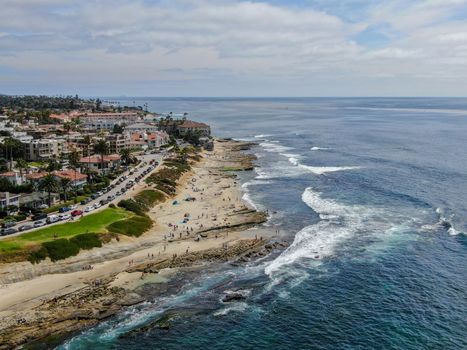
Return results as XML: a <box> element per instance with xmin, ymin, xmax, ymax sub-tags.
<box><xmin>0</xmin><ymin>0</ymin><xmax>467</xmax><ymax>97</ymax></box>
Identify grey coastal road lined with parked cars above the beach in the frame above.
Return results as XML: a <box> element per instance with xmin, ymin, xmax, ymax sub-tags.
<box><xmin>0</xmin><ymin>153</ymin><xmax>164</xmax><ymax>240</ymax></box>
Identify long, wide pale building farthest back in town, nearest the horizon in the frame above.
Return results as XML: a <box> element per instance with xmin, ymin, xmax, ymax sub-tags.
<box><xmin>80</xmin><ymin>112</ymin><xmax>140</xmax><ymax>130</ymax></box>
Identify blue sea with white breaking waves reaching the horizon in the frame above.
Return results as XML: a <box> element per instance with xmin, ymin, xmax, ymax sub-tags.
<box><xmin>59</xmin><ymin>98</ymin><xmax>467</xmax><ymax>350</ymax></box>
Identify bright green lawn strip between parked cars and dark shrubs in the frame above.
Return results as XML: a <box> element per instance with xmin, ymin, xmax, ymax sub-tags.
<box><xmin>0</xmin><ymin>208</ymin><xmax>133</xmax><ymax>253</ymax></box>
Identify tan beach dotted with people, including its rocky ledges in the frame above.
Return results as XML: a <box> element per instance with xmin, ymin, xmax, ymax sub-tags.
<box><xmin>0</xmin><ymin>141</ymin><xmax>286</xmax><ymax>348</ymax></box>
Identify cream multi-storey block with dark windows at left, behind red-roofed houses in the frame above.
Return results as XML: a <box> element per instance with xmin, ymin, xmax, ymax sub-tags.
<box><xmin>22</xmin><ymin>138</ymin><xmax>69</xmax><ymax>161</ymax></box>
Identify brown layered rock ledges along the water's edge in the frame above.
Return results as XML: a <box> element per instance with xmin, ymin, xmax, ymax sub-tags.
<box><xmin>0</xmin><ymin>140</ymin><xmax>287</xmax><ymax>349</ymax></box>
